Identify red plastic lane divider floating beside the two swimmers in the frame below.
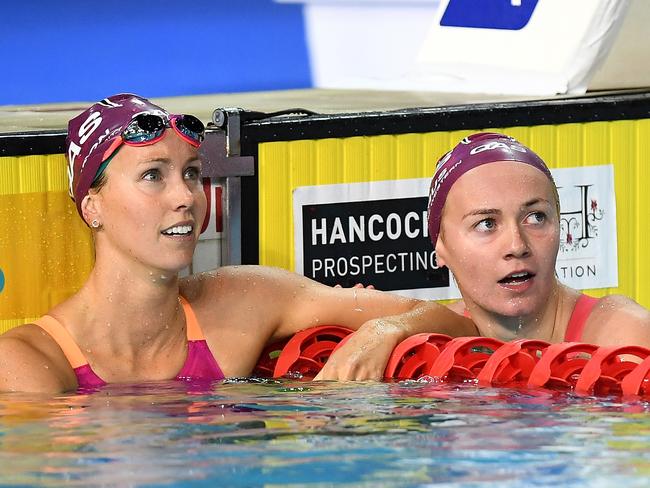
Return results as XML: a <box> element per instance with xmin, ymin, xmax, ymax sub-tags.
<box><xmin>254</xmin><ymin>325</ymin><xmax>650</xmax><ymax>398</ymax></box>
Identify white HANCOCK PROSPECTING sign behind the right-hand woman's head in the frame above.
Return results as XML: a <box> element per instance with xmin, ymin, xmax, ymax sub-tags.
<box><xmin>293</xmin><ymin>165</ymin><xmax>618</xmax><ymax>300</ymax></box>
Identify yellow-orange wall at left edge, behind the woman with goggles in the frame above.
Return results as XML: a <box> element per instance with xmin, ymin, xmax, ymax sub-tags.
<box><xmin>0</xmin><ymin>154</ymin><xmax>93</xmax><ymax>332</ymax></box>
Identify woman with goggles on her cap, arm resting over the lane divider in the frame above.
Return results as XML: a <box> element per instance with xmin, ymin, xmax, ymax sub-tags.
<box><xmin>0</xmin><ymin>94</ymin><xmax>476</xmax><ymax>393</ymax></box>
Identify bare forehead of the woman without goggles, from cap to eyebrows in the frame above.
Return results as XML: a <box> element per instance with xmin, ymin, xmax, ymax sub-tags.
<box><xmin>445</xmin><ymin>161</ymin><xmax>554</xmax><ymax>212</ymax></box>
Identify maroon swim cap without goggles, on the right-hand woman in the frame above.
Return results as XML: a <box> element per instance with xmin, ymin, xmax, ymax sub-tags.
<box><xmin>429</xmin><ymin>132</ymin><xmax>555</xmax><ymax>248</ymax></box>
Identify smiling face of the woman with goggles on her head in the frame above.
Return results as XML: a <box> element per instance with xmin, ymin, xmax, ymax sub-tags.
<box><xmin>89</xmin><ymin>130</ymin><xmax>206</xmax><ymax>272</ymax></box>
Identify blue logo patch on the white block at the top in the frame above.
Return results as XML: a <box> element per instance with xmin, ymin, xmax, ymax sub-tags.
<box><xmin>440</xmin><ymin>0</ymin><xmax>538</xmax><ymax>30</ymax></box>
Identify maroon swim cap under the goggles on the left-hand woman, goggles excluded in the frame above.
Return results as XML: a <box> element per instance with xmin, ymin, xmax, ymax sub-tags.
<box><xmin>65</xmin><ymin>93</ymin><xmax>169</xmax><ymax>218</ymax></box>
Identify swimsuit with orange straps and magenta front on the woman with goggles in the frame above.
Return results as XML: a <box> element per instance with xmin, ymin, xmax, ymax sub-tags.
<box><xmin>34</xmin><ymin>297</ymin><xmax>224</xmax><ymax>390</ymax></box>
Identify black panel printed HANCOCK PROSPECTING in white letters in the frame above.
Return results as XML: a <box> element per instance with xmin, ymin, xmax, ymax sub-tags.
<box><xmin>302</xmin><ymin>197</ymin><xmax>449</xmax><ymax>291</ymax></box>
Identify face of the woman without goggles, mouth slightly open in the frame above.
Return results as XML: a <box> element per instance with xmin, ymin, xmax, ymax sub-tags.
<box><xmin>436</xmin><ymin>161</ymin><xmax>559</xmax><ymax>317</ymax></box>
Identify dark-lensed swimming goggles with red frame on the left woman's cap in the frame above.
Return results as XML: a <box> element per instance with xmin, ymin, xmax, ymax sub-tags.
<box><xmin>122</xmin><ymin>113</ymin><xmax>205</xmax><ymax>147</ymax></box>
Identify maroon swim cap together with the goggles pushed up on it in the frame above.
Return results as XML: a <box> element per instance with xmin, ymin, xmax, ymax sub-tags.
<box><xmin>66</xmin><ymin>93</ymin><xmax>205</xmax><ymax>218</ymax></box>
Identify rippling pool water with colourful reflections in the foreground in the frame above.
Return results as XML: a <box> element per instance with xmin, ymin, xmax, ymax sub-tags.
<box><xmin>0</xmin><ymin>380</ymin><xmax>650</xmax><ymax>487</ymax></box>
